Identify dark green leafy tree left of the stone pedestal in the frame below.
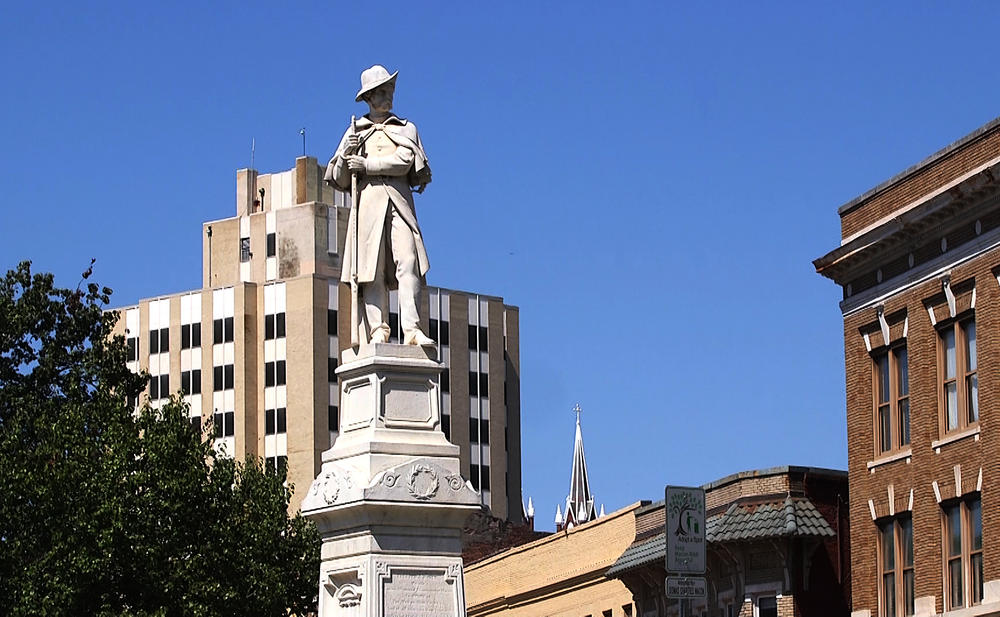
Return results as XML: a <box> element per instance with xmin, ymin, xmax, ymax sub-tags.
<box><xmin>0</xmin><ymin>262</ymin><xmax>319</xmax><ymax>616</ymax></box>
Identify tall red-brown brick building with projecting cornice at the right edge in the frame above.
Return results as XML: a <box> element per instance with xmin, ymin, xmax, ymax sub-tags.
<box><xmin>814</xmin><ymin>119</ymin><xmax>1000</xmax><ymax>617</ymax></box>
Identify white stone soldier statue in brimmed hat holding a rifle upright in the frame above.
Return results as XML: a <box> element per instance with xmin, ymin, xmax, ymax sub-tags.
<box><xmin>324</xmin><ymin>65</ymin><xmax>434</xmax><ymax>345</ymax></box>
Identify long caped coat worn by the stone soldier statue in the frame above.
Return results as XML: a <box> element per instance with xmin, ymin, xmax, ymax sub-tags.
<box><xmin>324</xmin><ymin>115</ymin><xmax>431</xmax><ymax>288</ymax></box>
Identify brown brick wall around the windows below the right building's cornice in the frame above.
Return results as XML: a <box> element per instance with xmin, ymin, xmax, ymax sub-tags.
<box><xmin>844</xmin><ymin>243</ymin><xmax>1000</xmax><ymax>615</ymax></box>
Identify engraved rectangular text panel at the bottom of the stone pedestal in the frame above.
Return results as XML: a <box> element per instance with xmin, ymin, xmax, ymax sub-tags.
<box><xmin>382</xmin><ymin>569</ymin><xmax>457</xmax><ymax>617</ymax></box>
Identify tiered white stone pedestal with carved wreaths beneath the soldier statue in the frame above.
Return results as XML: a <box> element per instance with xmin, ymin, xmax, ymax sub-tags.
<box><xmin>302</xmin><ymin>344</ymin><xmax>480</xmax><ymax>617</ymax></box>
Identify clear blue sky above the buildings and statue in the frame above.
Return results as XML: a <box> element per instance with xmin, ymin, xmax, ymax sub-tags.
<box><xmin>0</xmin><ymin>2</ymin><xmax>1000</xmax><ymax>528</ymax></box>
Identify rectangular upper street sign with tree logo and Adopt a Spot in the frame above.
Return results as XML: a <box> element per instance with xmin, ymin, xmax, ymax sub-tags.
<box><xmin>664</xmin><ymin>486</ymin><xmax>705</xmax><ymax>574</ymax></box>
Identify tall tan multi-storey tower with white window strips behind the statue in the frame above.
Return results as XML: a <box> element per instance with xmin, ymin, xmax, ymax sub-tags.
<box><xmin>111</xmin><ymin>157</ymin><xmax>523</xmax><ymax>522</ymax></box>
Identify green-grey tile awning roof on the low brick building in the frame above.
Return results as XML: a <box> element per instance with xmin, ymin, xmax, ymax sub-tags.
<box><xmin>607</xmin><ymin>497</ymin><xmax>836</xmax><ymax>576</ymax></box>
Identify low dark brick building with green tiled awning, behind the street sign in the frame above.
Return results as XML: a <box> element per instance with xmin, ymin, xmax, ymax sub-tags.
<box><xmin>604</xmin><ymin>467</ymin><xmax>851</xmax><ymax>617</ymax></box>
